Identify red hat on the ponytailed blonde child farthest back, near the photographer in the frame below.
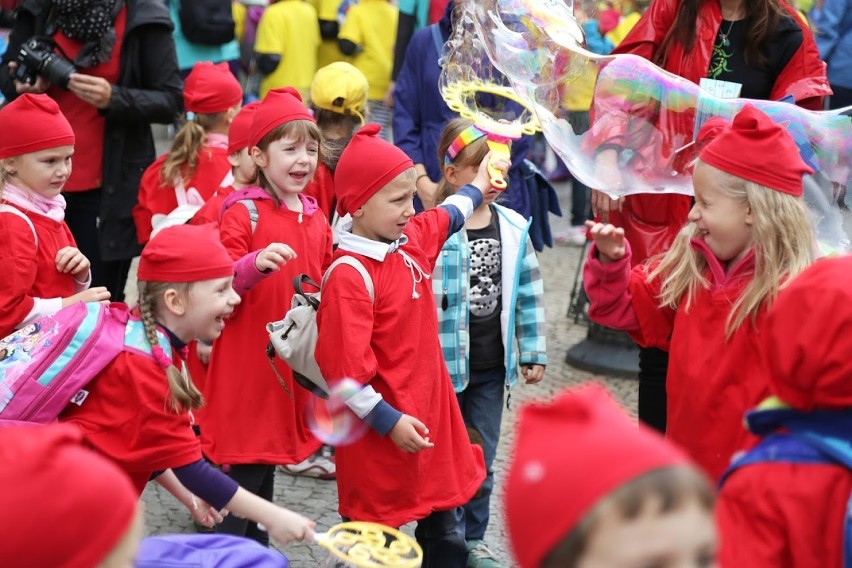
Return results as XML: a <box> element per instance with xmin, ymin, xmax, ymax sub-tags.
<box><xmin>183</xmin><ymin>61</ymin><xmax>243</xmax><ymax>114</ymax></box>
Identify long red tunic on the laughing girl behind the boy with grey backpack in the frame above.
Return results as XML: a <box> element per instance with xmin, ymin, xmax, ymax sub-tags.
<box><xmin>199</xmin><ymin>191</ymin><xmax>331</xmax><ymax>464</ymax></box>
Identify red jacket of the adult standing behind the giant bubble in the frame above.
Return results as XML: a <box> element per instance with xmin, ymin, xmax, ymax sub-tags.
<box><xmin>592</xmin><ymin>0</ymin><xmax>831</xmax><ymax>265</ymax></box>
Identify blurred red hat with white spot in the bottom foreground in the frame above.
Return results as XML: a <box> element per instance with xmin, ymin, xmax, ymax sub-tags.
<box><xmin>503</xmin><ymin>384</ymin><xmax>689</xmax><ymax>568</ymax></box>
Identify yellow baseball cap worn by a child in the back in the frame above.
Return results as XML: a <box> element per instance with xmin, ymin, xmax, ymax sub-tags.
<box><xmin>311</xmin><ymin>61</ymin><xmax>368</xmax><ymax>122</ymax></box>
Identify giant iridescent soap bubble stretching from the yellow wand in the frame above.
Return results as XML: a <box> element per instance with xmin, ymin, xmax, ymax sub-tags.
<box><xmin>441</xmin><ymin>0</ymin><xmax>852</xmax><ymax>250</ymax></box>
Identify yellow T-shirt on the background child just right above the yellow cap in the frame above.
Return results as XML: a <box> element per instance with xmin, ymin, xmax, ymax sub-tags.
<box><xmin>338</xmin><ymin>0</ymin><xmax>399</xmax><ymax>101</ymax></box>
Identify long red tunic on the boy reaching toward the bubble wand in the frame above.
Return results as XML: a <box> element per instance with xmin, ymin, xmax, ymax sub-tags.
<box><xmin>316</xmin><ymin>207</ymin><xmax>485</xmax><ymax>527</ymax></box>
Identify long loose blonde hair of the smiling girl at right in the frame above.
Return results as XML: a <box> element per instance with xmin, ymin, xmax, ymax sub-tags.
<box><xmin>648</xmin><ymin>162</ymin><xmax>814</xmax><ymax>339</ymax></box>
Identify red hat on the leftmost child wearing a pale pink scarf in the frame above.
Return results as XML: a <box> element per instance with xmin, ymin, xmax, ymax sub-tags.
<box><xmin>0</xmin><ymin>93</ymin><xmax>74</xmax><ymax>158</ymax></box>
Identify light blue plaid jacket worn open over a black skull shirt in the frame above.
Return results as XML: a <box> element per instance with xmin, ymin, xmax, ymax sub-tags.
<box><xmin>432</xmin><ymin>204</ymin><xmax>547</xmax><ymax>392</ymax></box>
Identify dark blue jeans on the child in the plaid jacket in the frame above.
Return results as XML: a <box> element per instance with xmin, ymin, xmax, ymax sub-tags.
<box><xmin>456</xmin><ymin>366</ymin><xmax>506</xmax><ymax>540</ymax></box>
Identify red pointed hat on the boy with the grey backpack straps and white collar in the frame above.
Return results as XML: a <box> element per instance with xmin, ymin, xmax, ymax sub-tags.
<box><xmin>334</xmin><ymin>123</ymin><xmax>414</xmax><ymax>215</ymax></box>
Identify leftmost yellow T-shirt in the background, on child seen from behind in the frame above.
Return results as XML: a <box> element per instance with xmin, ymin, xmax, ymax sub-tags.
<box><xmin>254</xmin><ymin>0</ymin><xmax>320</xmax><ymax>100</ymax></box>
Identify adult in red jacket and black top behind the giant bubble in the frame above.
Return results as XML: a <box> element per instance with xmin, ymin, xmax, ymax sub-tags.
<box><xmin>592</xmin><ymin>0</ymin><xmax>831</xmax><ymax>431</ymax></box>
